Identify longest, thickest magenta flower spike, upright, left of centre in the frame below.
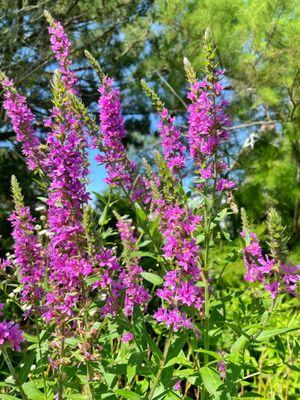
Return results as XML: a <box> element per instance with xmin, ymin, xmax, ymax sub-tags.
<box><xmin>45</xmin><ymin>76</ymin><xmax>92</xmax><ymax>319</ymax></box>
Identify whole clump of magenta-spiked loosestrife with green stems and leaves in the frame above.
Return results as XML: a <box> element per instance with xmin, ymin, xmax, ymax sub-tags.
<box><xmin>0</xmin><ymin>13</ymin><xmax>299</xmax><ymax>400</ymax></box>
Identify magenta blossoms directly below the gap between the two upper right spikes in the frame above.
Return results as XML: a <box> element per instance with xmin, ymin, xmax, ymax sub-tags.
<box><xmin>154</xmin><ymin>204</ymin><xmax>204</xmax><ymax>331</ymax></box>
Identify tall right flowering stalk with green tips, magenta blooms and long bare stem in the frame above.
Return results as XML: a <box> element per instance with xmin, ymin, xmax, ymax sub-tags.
<box><xmin>184</xmin><ymin>31</ymin><xmax>235</xmax><ymax>399</ymax></box>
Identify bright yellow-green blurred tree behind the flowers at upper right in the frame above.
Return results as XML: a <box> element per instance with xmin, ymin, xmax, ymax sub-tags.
<box><xmin>136</xmin><ymin>0</ymin><xmax>300</xmax><ymax>241</ymax></box>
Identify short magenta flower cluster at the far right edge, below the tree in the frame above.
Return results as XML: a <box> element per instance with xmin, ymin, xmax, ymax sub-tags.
<box><xmin>242</xmin><ymin>232</ymin><xmax>300</xmax><ymax>298</ymax></box>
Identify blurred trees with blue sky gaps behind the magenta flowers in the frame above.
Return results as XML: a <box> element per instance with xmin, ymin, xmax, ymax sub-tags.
<box><xmin>0</xmin><ymin>0</ymin><xmax>300</xmax><ymax>251</ymax></box>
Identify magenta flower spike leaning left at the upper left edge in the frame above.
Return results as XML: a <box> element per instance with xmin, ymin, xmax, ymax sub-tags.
<box><xmin>2</xmin><ymin>77</ymin><xmax>43</xmax><ymax>170</ymax></box>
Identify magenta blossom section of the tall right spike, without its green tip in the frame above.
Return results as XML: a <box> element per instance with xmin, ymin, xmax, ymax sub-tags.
<box><xmin>188</xmin><ymin>71</ymin><xmax>235</xmax><ymax>192</ymax></box>
